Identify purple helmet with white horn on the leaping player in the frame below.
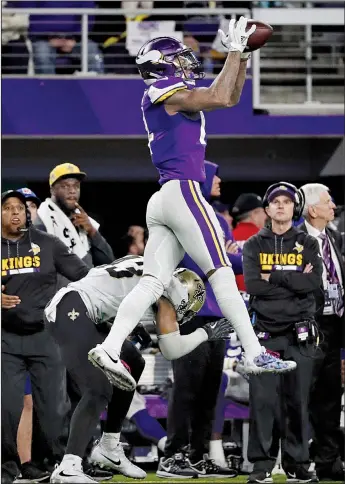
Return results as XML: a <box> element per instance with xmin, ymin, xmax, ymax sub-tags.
<box><xmin>136</xmin><ymin>37</ymin><xmax>205</xmax><ymax>81</ymax></box>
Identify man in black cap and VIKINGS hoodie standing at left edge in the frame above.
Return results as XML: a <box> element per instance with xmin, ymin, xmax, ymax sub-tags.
<box><xmin>1</xmin><ymin>190</ymin><xmax>89</xmax><ymax>482</ymax></box>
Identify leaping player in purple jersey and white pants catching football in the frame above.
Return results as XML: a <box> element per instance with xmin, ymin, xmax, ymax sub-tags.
<box><xmin>89</xmin><ymin>17</ymin><xmax>296</xmax><ymax>389</ymax></box>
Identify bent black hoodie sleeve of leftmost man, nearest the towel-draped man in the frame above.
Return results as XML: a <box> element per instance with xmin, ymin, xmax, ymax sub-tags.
<box><xmin>53</xmin><ymin>237</ymin><xmax>89</xmax><ymax>281</ymax></box>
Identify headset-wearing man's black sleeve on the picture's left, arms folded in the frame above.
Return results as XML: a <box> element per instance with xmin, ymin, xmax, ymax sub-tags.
<box><xmin>243</xmin><ymin>236</ymin><xmax>294</xmax><ymax>299</ymax></box>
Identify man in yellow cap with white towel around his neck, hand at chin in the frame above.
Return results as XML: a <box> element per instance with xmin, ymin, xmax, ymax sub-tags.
<box><xmin>35</xmin><ymin>163</ymin><xmax>114</xmax><ymax>267</ymax></box>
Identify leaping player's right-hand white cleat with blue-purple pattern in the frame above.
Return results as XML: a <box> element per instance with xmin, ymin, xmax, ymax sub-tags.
<box><xmin>236</xmin><ymin>350</ymin><xmax>297</xmax><ymax>375</ymax></box>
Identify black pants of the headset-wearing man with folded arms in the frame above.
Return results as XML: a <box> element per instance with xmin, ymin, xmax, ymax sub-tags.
<box><xmin>248</xmin><ymin>333</ymin><xmax>315</xmax><ymax>472</ymax></box>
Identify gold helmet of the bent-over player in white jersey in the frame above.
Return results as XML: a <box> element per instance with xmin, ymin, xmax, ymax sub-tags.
<box><xmin>165</xmin><ymin>267</ymin><xmax>206</xmax><ymax>324</ymax></box>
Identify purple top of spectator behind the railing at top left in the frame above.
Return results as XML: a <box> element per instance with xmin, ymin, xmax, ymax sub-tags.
<box><xmin>7</xmin><ymin>0</ymin><xmax>96</xmax><ymax>38</ymax></box>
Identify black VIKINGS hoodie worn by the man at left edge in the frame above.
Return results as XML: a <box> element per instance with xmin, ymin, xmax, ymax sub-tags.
<box><xmin>1</xmin><ymin>227</ymin><xmax>89</xmax><ymax>334</ymax></box>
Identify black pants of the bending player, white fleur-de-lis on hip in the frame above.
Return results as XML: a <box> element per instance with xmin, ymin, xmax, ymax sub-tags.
<box><xmin>50</xmin><ymin>291</ymin><xmax>145</xmax><ymax>457</ymax></box>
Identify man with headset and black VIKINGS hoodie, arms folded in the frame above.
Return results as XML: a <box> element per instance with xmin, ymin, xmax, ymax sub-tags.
<box><xmin>243</xmin><ymin>182</ymin><xmax>322</xmax><ymax>483</ymax></box>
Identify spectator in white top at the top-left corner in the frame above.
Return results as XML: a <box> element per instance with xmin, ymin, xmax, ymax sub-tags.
<box><xmin>1</xmin><ymin>1</ymin><xmax>29</xmax><ymax>74</ymax></box>
